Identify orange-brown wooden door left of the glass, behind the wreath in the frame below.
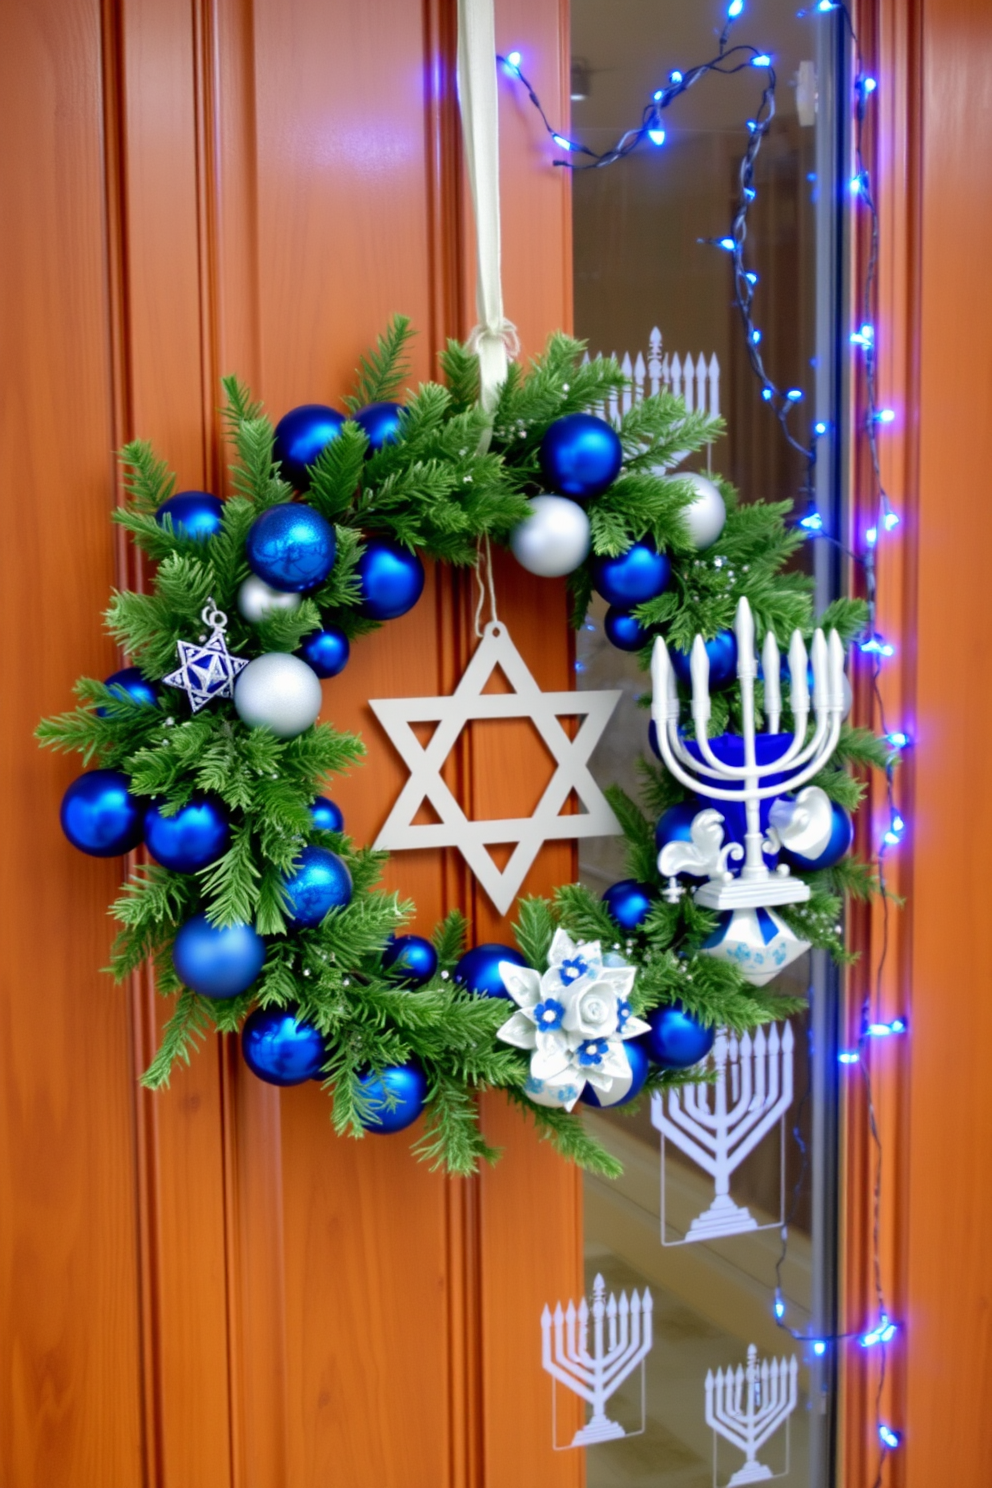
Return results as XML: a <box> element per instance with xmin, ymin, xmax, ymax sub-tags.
<box><xmin>0</xmin><ymin>0</ymin><xmax>582</xmax><ymax>1488</ymax></box>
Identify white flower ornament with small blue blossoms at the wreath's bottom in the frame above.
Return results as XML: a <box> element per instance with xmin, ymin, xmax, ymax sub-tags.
<box><xmin>498</xmin><ymin>930</ymin><xmax>648</xmax><ymax>1110</ymax></box>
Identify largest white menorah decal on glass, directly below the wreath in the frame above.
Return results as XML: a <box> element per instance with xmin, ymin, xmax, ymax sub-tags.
<box><xmin>651</xmin><ymin>1022</ymin><xmax>796</xmax><ymax>1245</ymax></box>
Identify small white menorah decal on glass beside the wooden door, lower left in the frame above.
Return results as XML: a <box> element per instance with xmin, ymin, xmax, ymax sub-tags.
<box><xmin>541</xmin><ymin>1277</ymin><xmax>654</xmax><ymax>1451</ymax></box>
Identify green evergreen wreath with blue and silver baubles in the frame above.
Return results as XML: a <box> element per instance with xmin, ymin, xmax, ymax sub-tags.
<box><xmin>39</xmin><ymin>317</ymin><xmax>888</xmax><ymax>1174</ymax></box>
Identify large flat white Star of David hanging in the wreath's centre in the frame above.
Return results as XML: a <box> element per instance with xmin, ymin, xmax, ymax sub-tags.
<box><xmin>369</xmin><ymin>620</ymin><xmax>622</xmax><ymax>915</ymax></box>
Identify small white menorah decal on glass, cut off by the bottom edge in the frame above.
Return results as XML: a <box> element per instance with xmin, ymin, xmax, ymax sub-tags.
<box><xmin>706</xmin><ymin>1344</ymin><xmax>799</xmax><ymax>1488</ymax></box>
